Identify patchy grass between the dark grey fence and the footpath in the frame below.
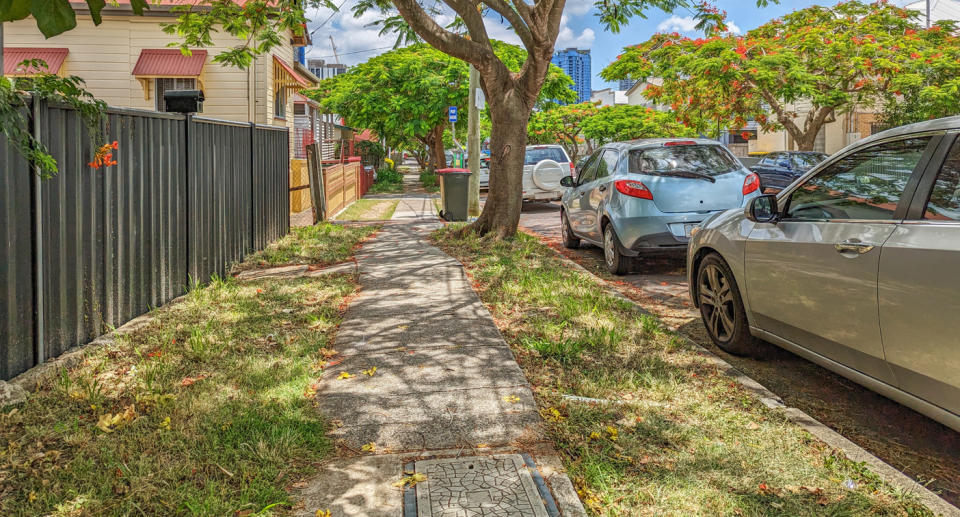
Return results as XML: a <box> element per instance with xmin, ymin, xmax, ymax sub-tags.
<box><xmin>0</xmin><ymin>253</ymin><xmax>356</xmax><ymax>515</ymax></box>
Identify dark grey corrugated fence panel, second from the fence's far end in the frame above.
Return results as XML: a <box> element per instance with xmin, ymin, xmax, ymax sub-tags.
<box><xmin>187</xmin><ymin>118</ymin><xmax>253</xmax><ymax>282</ymax></box>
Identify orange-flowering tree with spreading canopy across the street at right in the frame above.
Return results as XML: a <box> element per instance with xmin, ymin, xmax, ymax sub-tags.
<box><xmin>601</xmin><ymin>0</ymin><xmax>960</xmax><ymax>150</ymax></box>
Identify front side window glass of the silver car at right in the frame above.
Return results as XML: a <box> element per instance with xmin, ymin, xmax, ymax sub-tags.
<box><xmin>787</xmin><ymin>137</ymin><xmax>930</xmax><ymax>220</ymax></box>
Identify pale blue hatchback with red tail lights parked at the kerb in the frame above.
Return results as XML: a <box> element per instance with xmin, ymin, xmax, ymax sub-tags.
<box><xmin>560</xmin><ymin>139</ymin><xmax>760</xmax><ymax>274</ymax></box>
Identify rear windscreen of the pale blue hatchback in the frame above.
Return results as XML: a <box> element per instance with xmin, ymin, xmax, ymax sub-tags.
<box><xmin>628</xmin><ymin>145</ymin><xmax>741</xmax><ymax>176</ymax></box>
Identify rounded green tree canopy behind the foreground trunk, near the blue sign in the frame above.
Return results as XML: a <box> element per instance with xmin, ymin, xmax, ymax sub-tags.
<box><xmin>307</xmin><ymin>42</ymin><xmax>576</xmax><ymax>167</ymax></box>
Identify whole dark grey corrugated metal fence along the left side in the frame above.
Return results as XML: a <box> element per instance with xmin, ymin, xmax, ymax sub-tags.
<box><xmin>0</xmin><ymin>98</ymin><xmax>289</xmax><ymax>379</ymax></box>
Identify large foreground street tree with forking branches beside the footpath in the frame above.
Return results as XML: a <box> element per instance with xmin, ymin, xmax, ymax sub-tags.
<box><xmin>354</xmin><ymin>0</ymin><xmax>769</xmax><ymax>237</ymax></box>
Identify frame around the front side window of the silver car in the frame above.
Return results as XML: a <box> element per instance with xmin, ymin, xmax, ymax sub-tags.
<box><xmin>777</xmin><ymin>131</ymin><xmax>947</xmax><ymax>224</ymax></box>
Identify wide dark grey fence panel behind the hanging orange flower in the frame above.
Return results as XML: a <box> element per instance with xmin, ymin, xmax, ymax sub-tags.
<box><xmin>37</xmin><ymin>106</ymin><xmax>186</xmax><ymax>357</ymax></box>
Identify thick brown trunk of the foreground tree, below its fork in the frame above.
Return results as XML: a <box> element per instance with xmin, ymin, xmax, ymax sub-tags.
<box><xmin>469</xmin><ymin>90</ymin><xmax>531</xmax><ymax>238</ymax></box>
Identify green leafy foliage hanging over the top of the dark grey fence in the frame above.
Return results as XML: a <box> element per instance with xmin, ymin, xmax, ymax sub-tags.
<box><xmin>0</xmin><ymin>59</ymin><xmax>107</xmax><ymax>179</ymax></box>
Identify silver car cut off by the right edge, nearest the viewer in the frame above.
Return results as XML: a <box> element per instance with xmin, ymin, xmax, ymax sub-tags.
<box><xmin>688</xmin><ymin>117</ymin><xmax>960</xmax><ymax>431</ymax></box>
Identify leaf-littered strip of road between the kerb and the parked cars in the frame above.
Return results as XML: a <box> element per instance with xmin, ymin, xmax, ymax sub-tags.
<box><xmin>520</xmin><ymin>202</ymin><xmax>960</xmax><ymax>506</ymax></box>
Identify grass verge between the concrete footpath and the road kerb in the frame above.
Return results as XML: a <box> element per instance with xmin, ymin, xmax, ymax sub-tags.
<box><xmin>434</xmin><ymin>225</ymin><xmax>930</xmax><ymax>515</ymax></box>
